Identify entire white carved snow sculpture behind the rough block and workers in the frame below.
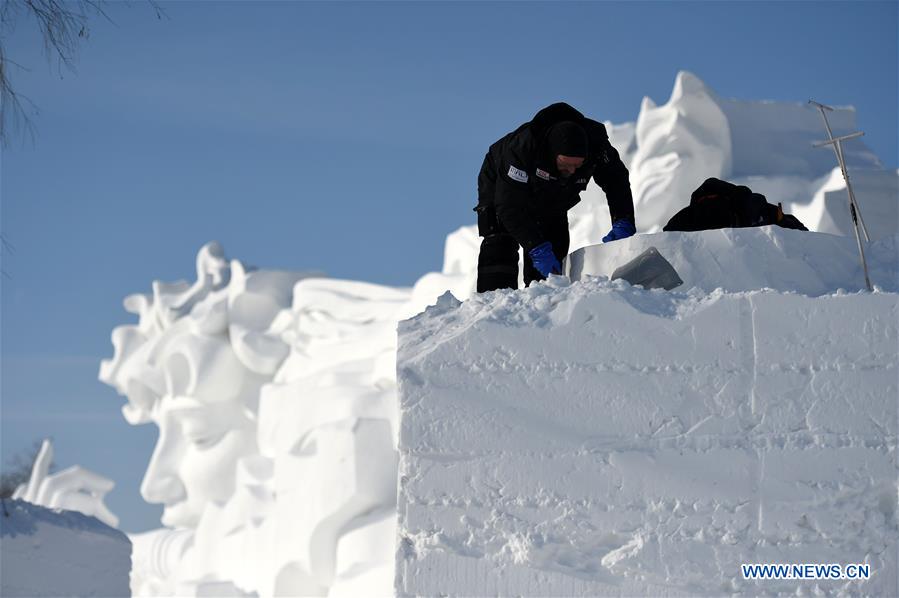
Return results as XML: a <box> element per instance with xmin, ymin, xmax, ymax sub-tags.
<box><xmin>100</xmin><ymin>73</ymin><xmax>899</xmax><ymax>596</ymax></box>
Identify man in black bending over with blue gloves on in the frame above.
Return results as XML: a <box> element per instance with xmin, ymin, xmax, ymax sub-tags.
<box><xmin>475</xmin><ymin>102</ymin><xmax>635</xmax><ymax>293</ymax></box>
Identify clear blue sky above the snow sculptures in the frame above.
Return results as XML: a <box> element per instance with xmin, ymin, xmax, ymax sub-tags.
<box><xmin>0</xmin><ymin>2</ymin><xmax>899</xmax><ymax>531</ymax></box>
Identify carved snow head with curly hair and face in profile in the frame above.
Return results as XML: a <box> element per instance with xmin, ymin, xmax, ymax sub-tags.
<box><xmin>100</xmin><ymin>243</ymin><xmax>278</xmax><ymax>527</ymax></box>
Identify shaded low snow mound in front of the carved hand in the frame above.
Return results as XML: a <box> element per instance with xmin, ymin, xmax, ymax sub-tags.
<box><xmin>0</xmin><ymin>500</ymin><xmax>131</xmax><ymax>597</ymax></box>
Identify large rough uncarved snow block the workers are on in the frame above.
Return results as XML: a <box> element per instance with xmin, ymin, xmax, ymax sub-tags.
<box><xmin>396</xmin><ymin>229</ymin><xmax>899</xmax><ymax>596</ymax></box>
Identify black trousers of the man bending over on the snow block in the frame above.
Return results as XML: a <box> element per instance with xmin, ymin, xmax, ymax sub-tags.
<box><xmin>478</xmin><ymin>207</ymin><xmax>569</xmax><ymax>293</ymax></box>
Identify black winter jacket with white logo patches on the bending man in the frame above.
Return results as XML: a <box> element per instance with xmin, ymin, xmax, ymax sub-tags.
<box><xmin>475</xmin><ymin>102</ymin><xmax>634</xmax><ymax>251</ymax></box>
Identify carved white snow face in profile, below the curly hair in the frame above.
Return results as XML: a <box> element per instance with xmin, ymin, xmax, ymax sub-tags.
<box><xmin>141</xmin><ymin>336</ymin><xmax>262</xmax><ymax>527</ymax></box>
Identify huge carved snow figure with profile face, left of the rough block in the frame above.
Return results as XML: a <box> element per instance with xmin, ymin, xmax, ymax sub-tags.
<box><xmin>100</xmin><ymin>243</ymin><xmax>411</xmax><ymax>596</ymax></box>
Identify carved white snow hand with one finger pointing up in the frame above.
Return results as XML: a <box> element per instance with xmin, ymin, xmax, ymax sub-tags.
<box><xmin>12</xmin><ymin>440</ymin><xmax>119</xmax><ymax>527</ymax></box>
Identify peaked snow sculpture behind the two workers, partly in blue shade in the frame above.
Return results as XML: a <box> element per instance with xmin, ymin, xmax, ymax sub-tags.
<box><xmin>570</xmin><ymin>71</ymin><xmax>899</xmax><ymax>244</ymax></box>
